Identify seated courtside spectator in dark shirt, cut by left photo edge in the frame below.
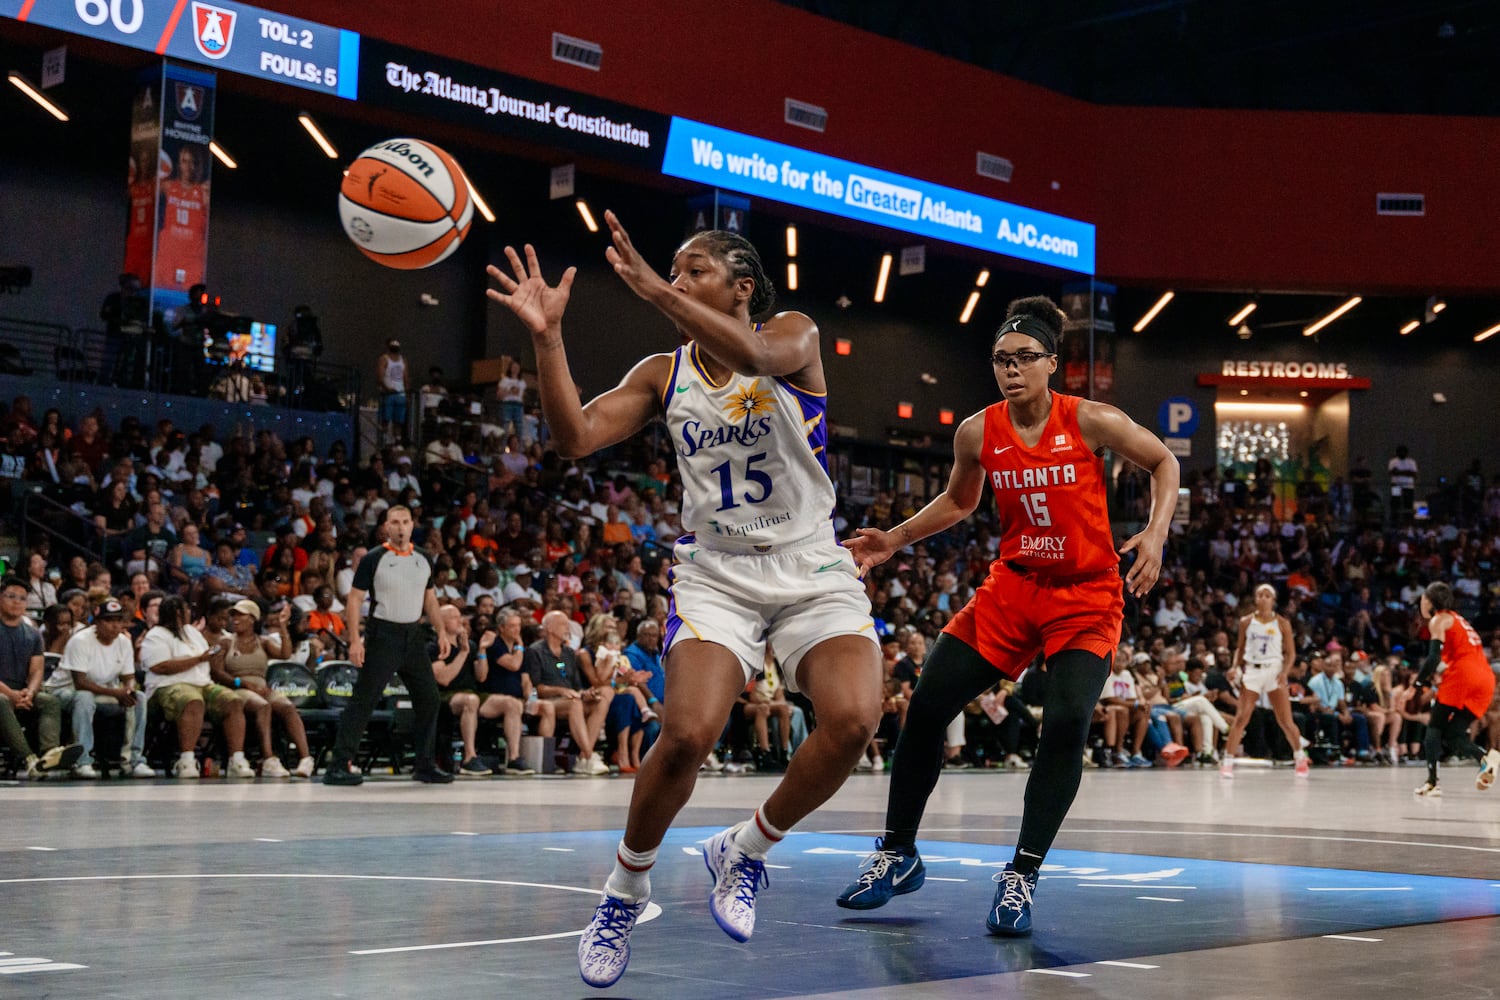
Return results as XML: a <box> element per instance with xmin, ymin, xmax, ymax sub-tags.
<box><xmin>0</xmin><ymin>576</ymin><xmax>83</xmax><ymax>778</ymax></box>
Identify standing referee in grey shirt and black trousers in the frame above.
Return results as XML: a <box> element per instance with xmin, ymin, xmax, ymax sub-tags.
<box><xmin>323</xmin><ymin>505</ymin><xmax>453</xmax><ymax>784</ymax></box>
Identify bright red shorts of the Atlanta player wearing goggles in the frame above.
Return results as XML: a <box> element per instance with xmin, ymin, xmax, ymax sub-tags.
<box><xmin>944</xmin><ymin>564</ymin><xmax>1125</xmax><ymax>679</ymax></box>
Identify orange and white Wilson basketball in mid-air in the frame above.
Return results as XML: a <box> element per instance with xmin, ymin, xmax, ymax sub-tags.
<box><xmin>339</xmin><ymin>139</ymin><xmax>474</xmax><ymax>270</ymax></box>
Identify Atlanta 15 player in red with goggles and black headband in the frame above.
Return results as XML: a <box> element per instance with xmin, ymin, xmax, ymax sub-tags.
<box><xmin>839</xmin><ymin>295</ymin><xmax>1178</xmax><ymax>936</ymax></box>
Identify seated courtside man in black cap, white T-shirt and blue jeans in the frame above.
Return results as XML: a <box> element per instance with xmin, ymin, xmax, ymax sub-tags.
<box><xmin>48</xmin><ymin>598</ymin><xmax>156</xmax><ymax>778</ymax></box>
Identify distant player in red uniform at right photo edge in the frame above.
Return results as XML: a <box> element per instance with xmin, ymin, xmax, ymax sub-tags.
<box><xmin>1416</xmin><ymin>583</ymin><xmax>1500</xmax><ymax>798</ymax></box>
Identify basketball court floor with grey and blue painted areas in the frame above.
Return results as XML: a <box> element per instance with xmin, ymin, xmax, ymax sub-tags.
<box><xmin>0</xmin><ymin>766</ymin><xmax>1500</xmax><ymax>1000</ymax></box>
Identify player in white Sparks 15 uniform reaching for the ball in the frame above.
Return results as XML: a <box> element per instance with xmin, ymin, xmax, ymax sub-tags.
<box><xmin>488</xmin><ymin>213</ymin><xmax>882</xmax><ymax>987</ymax></box>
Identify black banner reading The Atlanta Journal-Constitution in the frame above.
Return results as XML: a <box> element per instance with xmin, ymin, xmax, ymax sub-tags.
<box><xmin>360</xmin><ymin>37</ymin><xmax>668</xmax><ymax>171</ymax></box>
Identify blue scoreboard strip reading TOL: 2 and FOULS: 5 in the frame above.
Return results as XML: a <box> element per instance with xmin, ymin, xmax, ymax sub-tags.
<box><xmin>0</xmin><ymin>0</ymin><xmax>360</xmax><ymax>100</ymax></box>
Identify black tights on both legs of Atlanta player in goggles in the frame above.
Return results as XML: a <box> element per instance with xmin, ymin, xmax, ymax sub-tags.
<box><xmin>885</xmin><ymin>633</ymin><xmax>1110</xmax><ymax>873</ymax></box>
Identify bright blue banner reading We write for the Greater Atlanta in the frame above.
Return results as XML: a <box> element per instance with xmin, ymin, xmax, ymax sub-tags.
<box><xmin>662</xmin><ymin>118</ymin><xmax>1094</xmax><ymax>274</ymax></box>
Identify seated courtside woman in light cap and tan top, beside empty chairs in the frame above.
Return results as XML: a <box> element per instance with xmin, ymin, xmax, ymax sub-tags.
<box><xmin>210</xmin><ymin>601</ymin><xmax>314</xmax><ymax>778</ymax></box>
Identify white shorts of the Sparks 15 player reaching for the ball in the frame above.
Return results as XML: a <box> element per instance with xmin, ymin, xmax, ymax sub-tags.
<box><xmin>662</xmin><ymin>538</ymin><xmax>879</xmax><ymax>691</ymax></box>
